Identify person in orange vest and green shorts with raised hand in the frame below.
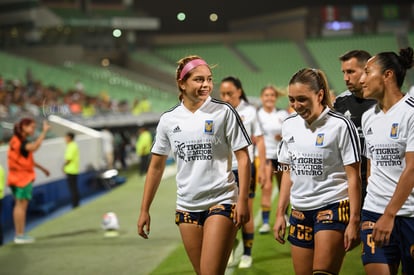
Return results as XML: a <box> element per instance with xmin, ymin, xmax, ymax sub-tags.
<box><xmin>7</xmin><ymin>118</ymin><xmax>50</xmax><ymax>244</ymax></box>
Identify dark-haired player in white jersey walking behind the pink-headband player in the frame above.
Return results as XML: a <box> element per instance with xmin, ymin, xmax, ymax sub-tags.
<box><xmin>219</xmin><ymin>76</ymin><xmax>266</xmax><ymax>268</ymax></box>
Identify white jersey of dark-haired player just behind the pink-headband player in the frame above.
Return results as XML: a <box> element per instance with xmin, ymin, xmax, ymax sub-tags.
<box><xmin>232</xmin><ymin>100</ymin><xmax>263</xmax><ymax>170</ymax></box>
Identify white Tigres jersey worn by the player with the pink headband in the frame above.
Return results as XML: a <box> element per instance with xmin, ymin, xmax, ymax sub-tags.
<box><xmin>151</xmin><ymin>97</ymin><xmax>251</xmax><ymax>211</ymax></box>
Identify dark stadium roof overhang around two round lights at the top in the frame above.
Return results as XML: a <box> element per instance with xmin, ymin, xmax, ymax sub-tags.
<box><xmin>135</xmin><ymin>0</ymin><xmax>412</xmax><ymax>32</ymax></box>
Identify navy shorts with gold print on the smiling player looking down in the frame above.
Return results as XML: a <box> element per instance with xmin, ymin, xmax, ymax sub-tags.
<box><xmin>288</xmin><ymin>200</ymin><xmax>349</xmax><ymax>248</ymax></box>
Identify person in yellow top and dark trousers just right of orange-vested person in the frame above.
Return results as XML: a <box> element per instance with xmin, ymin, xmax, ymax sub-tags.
<box><xmin>63</xmin><ymin>132</ymin><xmax>80</xmax><ymax>208</ymax></box>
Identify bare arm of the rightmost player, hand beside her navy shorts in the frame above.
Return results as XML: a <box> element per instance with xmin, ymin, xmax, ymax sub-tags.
<box><xmin>372</xmin><ymin>152</ymin><xmax>414</xmax><ymax>246</ymax></box>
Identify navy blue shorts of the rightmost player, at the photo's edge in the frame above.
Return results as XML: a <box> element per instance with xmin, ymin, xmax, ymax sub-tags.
<box><xmin>361</xmin><ymin>210</ymin><xmax>414</xmax><ymax>274</ymax></box>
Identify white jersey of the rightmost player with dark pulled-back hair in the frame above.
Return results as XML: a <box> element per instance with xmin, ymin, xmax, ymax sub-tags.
<box><xmin>362</xmin><ymin>95</ymin><xmax>414</xmax><ymax>217</ymax></box>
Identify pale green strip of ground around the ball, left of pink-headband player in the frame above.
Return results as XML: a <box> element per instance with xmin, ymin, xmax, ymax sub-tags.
<box><xmin>0</xmin><ymin>166</ymin><xmax>181</xmax><ymax>275</ymax></box>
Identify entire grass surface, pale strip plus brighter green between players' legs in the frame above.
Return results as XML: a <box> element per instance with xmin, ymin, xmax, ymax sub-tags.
<box><xmin>0</xmin><ymin>167</ymin><xmax>364</xmax><ymax>275</ymax></box>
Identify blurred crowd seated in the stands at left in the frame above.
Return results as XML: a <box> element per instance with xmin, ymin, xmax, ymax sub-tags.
<box><xmin>0</xmin><ymin>72</ymin><xmax>151</xmax><ymax>119</ymax></box>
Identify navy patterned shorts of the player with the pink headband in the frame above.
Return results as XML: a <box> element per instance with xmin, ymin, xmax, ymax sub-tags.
<box><xmin>175</xmin><ymin>204</ymin><xmax>236</xmax><ymax>226</ymax></box>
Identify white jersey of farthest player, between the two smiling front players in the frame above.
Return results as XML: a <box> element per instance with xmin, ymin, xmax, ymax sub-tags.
<box><xmin>257</xmin><ymin>108</ymin><xmax>289</xmax><ymax>159</ymax></box>
